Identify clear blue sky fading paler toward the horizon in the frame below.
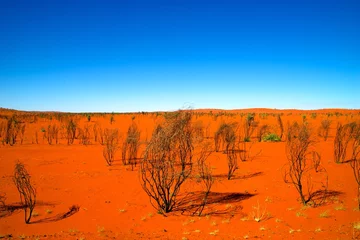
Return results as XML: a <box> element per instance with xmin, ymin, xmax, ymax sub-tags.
<box><xmin>0</xmin><ymin>0</ymin><xmax>360</xmax><ymax>112</ymax></box>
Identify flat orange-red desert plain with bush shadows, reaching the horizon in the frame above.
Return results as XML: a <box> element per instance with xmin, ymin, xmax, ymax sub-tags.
<box><xmin>0</xmin><ymin>109</ymin><xmax>360</xmax><ymax>240</ymax></box>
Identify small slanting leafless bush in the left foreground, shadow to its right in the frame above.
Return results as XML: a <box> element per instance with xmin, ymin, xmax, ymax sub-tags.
<box><xmin>13</xmin><ymin>162</ymin><xmax>36</xmax><ymax>224</ymax></box>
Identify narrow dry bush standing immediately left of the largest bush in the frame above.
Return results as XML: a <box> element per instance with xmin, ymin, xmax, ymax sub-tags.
<box><xmin>122</xmin><ymin>122</ymin><xmax>140</xmax><ymax>170</ymax></box>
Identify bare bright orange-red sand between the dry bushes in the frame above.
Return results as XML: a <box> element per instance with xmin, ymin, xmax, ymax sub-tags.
<box><xmin>0</xmin><ymin>109</ymin><xmax>360</xmax><ymax>239</ymax></box>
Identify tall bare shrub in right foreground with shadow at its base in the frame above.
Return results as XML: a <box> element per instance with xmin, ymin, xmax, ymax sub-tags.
<box><xmin>283</xmin><ymin>122</ymin><xmax>328</xmax><ymax>206</ymax></box>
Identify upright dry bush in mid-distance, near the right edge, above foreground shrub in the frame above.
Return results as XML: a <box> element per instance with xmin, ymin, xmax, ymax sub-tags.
<box><xmin>334</xmin><ymin>122</ymin><xmax>357</xmax><ymax>163</ymax></box>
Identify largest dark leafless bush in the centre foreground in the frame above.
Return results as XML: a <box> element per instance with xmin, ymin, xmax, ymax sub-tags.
<box><xmin>140</xmin><ymin>111</ymin><xmax>193</xmax><ymax>213</ymax></box>
